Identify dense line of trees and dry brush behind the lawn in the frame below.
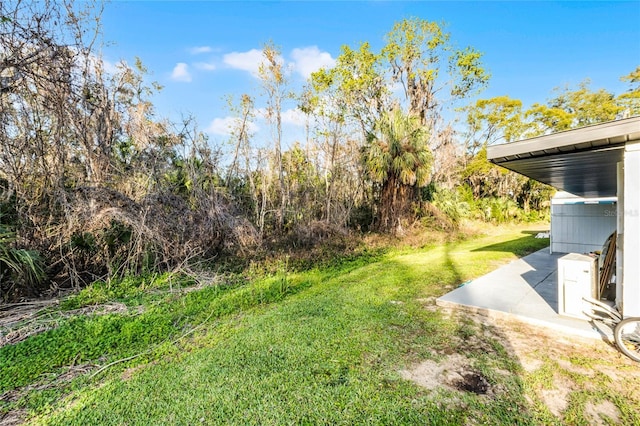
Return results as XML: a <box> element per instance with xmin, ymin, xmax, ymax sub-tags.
<box><xmin>0</xmin><ymin>0</ymin><xmax>640</xmax><ymax>301</ymax></box>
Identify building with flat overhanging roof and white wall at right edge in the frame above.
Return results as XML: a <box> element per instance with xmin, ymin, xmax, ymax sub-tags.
<box><xmin>487</xmin><ymin>117</ymin><xmax>640</xmax><ymax>317</ymax></box>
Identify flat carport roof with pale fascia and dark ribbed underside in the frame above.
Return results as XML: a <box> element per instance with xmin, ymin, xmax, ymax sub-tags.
<box><xmin>487</xmin><ymin>116</ymin><xmax>640</xmax><ymax>197</ymax></box>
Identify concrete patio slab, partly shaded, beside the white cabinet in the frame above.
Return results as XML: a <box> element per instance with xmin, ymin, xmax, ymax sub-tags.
<box><xmin>436</xmin><ymin>248</ymin><xmax>611</xmax><ymax>339</ymax></box>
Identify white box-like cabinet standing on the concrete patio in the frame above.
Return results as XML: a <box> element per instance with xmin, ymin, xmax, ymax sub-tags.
<box><xmin>558</xmin><ymin>253</ymin><xmax>598</xmax><ymax>320</ymax></box>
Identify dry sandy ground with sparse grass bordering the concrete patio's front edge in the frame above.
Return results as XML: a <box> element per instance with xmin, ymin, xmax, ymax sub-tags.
<box><xmin>464</xmin><ymin>313</ymin><xmax>640</xmax><ymax>425</ymax></box>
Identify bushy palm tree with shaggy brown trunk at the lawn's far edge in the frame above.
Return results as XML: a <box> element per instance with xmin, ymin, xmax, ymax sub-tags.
<box><xmin>363</xmin><ymin>108</ymin><xmax>432</xmax><ymax>231</ymax></box>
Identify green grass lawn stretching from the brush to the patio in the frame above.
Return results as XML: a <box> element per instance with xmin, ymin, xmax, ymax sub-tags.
<box><xmin>0</xmin><ymin>221</ymin><xmax>640</xmax><ymax>425</ymax></box>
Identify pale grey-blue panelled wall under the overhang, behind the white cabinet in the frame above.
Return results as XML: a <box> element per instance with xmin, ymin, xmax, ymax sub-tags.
<box><xmin>550</xmin><ymin>201</ymin><xmax>617</xmax><ymax>253</ymax></box>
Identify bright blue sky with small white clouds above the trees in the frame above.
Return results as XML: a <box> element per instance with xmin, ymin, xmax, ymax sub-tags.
<box><xmin>103</xmin><ymin>0</ymin><xmax>640</xmax><ymax>144</ymax></box>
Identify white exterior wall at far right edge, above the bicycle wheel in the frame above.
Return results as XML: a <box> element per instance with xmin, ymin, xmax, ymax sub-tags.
<box><xmin>621</xmin><ymin>142</ymin><xmax>640</xmax><ymax>317</ymax></box>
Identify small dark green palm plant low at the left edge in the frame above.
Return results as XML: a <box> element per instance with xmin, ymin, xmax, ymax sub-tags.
<box><xmin>0</xmin><ymin>223</ymin><xmax>46</xmax><ymax>299</ymax></box>
